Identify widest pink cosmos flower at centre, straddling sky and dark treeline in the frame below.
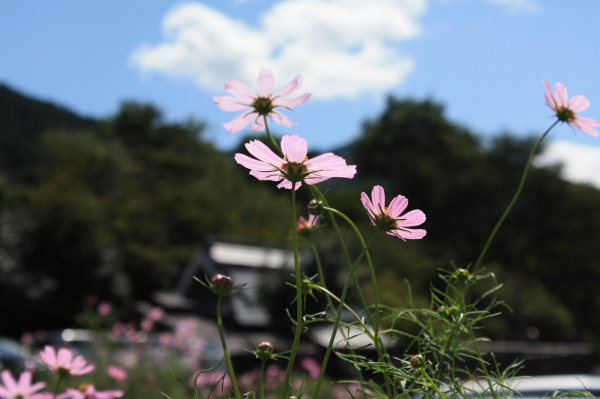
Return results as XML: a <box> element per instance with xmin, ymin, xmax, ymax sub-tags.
<box><xmin>235</xmin><ymin>135</ymin><xmax>356</xmax><ymax>190</ymax></box>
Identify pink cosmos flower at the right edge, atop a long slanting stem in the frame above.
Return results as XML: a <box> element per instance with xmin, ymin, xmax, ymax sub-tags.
<box><xmin>544</xmin><ymin>80</ymin><xmax>600</xmax><ymax>137</ymax></box>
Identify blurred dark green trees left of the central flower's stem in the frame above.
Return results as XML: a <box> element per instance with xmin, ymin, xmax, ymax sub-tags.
<box><xmin>0</xmin><ymin>86</ymin><xmax>291</xmax><ymax>334</ymax></box>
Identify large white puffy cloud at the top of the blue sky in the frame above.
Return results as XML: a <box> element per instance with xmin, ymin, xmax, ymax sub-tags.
<box><xmin>132</xmin><ymin>0</ymin><xmax>427</xmax><ymax>99</ymax></box>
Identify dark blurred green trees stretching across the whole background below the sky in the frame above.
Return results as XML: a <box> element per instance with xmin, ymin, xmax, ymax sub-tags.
<box><xmin>0</xmin><ymin>84</ymin><xmax>600</xmax><ymax>354</ymax></box>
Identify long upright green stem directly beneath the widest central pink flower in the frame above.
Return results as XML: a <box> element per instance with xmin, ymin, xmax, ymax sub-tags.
<box><xmin>284</xmin><ymin>182</ymin><xmax>304</xmax><ymax>398</ymax></box>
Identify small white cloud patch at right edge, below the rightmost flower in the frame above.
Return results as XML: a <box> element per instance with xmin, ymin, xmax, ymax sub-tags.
<box><xmin>536</xmin><ymin>141</ymin><xmax>600</xmax><ymax>188</ymax></box>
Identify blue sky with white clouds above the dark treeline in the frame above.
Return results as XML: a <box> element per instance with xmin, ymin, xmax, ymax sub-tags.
<box><xmin>0</xmin><ymin>0</ymin><xmax>600</xmax><ymax>185</ymax></box>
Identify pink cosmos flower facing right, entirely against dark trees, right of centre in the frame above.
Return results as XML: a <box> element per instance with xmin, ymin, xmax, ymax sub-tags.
<box><xmin>360</xmin><ymin>186</ymin><xmax>427</xmax><ymax>240</ymax></box>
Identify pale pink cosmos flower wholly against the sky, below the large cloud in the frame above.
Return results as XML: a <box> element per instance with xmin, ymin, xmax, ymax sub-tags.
<box><xmin>214</xmin><ymin>69</ymin><xmax>311</xmax><ymax>133</ymax></box>
